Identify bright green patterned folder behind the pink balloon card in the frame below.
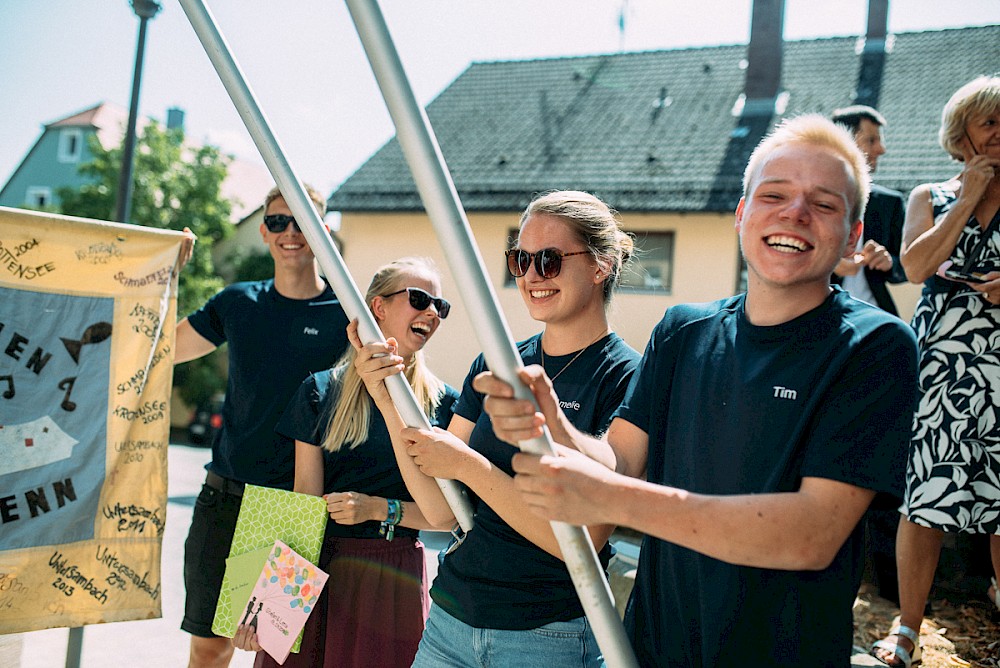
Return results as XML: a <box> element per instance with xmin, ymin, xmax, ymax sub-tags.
<box><xmin>212</xmin><ymin>485</ymin><xmax>327</xmax><ymax>652</ymax></box>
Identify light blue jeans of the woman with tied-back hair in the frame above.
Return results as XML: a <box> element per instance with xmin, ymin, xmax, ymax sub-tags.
<box><xmin>413</xmin><ymin>605</ymin><xmax>604</xmax><ymax>668</ymax></box>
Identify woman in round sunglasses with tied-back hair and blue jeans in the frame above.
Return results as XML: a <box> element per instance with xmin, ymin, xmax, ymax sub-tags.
<box><xmin>359</xmin><ymin>191</ymin><xmax>639</xmax><ymax>668</ymax></box>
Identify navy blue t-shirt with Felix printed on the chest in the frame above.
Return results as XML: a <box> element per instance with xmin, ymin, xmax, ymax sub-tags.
<box><xmin>188</xmin><ymin>280</ymin><xmax>348</xmax><ymax>489</ymax></box>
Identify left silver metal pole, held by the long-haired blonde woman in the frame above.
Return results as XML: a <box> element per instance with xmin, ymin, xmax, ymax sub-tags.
<box><xmin>180</xmin><ymin>0</ymin><xmax>472</xmax><ymax>531</ymax></box>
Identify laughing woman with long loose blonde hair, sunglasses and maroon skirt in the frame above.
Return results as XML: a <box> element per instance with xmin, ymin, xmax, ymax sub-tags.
<box><xmin>233</xmin><ymin>258</ymin><xmax>458</xmax><ymax>668</ymax></box>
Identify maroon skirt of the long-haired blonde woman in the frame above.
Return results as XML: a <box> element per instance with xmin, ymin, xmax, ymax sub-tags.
<box><xmin>254</xmin><ymin>536</ymin><xmax>430</xmax><ymax>668</ymax></box>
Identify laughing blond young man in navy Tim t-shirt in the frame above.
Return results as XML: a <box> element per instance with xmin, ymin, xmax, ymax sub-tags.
<box><xmin>477</xmin><ymin>115</ymin><xmax>916</xmax><ymax>667</ymax></box>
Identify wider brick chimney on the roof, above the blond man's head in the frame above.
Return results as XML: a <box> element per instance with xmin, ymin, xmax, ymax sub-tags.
<box><xmin>741</xmin><ymin>0</ymin><xmax>785</xmax><ymax>117</ymax></box>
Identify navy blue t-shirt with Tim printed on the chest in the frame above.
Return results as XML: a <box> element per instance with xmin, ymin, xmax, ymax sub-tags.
<box><xmin>616</xmin><ymin>287</ymin><xmax>917</xmax><ymax>667</ymax></box>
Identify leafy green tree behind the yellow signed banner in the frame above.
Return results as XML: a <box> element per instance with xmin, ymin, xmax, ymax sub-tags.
<box><xmin>58</xmin><ymin>121</ymin><xmax>232</xmax><ymax>404</ymax></box>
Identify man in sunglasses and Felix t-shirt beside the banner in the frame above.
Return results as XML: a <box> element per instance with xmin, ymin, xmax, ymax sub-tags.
<box><xmin>174</xmin><ymin>187</ymin><xmax>352</xmax><ymax>668</ymax></box>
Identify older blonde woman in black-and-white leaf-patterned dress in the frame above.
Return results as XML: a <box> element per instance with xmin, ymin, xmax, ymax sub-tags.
<box><xmin>872</xmin><ymin>76</ymin><xmax>1000</xmax><ymax>668</ymax></box>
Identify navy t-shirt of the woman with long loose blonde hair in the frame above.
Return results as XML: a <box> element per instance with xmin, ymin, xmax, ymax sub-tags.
<box><xmin>275</xmin><ymin>371</ymin><xmax>458</xmax><ymax>538</ymax></box>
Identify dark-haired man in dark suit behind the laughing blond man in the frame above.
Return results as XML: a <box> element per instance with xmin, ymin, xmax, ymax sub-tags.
<box><xmin>831</xmin><ymin>104</ymin><xmax>906</xmax><ymax>315</ymax></box>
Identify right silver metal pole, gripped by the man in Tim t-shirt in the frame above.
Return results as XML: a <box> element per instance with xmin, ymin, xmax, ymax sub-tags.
<box><xmin>346</xmin><ymin>0</ymin><xmax>637</xmax><ymax>667</ymax></box>
